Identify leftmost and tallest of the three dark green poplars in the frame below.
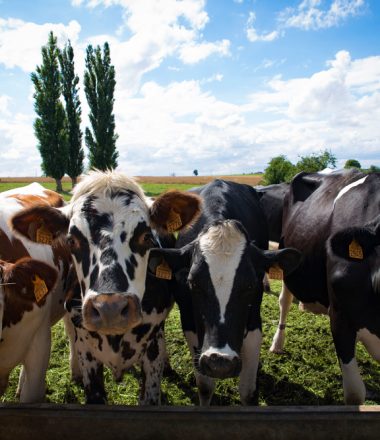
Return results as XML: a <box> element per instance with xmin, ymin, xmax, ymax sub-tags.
<box><xmin>31</xmin><ymin>32</ymin><xmax>67</xmax><ymax>192</ymax></box>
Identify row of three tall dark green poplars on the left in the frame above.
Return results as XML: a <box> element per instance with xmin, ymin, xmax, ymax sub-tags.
<box><xmin>31</xmin><ymin>32</ymin><xmax>118</xmax><ymax>192</ymax></box>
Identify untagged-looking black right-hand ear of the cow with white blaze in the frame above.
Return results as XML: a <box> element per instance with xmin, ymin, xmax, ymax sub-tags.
<box><xmin>250</xmin><ymin>242</ymin><xmax>302</xmax><ymax>275</ymax></box>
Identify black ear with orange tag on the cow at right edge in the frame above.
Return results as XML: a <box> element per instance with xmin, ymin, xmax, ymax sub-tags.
<box><xmin>328</xmin><ymin>227</ymin><xmax>380</xmax><ymax>261</ymax></box>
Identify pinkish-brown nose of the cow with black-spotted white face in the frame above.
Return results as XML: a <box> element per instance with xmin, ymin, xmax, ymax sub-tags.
<box><xmin>83</xmin><ymin>293</ymin><xmax>142</xmax><ymax>334</ymax></box>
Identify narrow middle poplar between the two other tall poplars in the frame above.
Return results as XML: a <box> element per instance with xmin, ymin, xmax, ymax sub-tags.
<box><xmin>59</xmin><ymin>40</ymin><xmax>84</xmax><ymax>186</ymax></box>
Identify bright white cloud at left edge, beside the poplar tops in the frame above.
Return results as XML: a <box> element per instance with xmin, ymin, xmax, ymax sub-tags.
<box><xmin>0</xmin><ymin>18</ymin><xmax>81</xmax><ymax>72</ymax></box>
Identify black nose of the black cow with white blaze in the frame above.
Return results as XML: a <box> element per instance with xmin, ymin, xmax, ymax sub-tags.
<box><xmin>199</xmin><ymin>353</ymin><xmax>241</xmax><ymax>379</ymax></box>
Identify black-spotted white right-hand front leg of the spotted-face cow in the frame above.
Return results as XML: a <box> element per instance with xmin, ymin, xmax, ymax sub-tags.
<box><xmin>139</xmin><ymin>327</ymin><xmax>166</xmax><ymax>405</ymax></box>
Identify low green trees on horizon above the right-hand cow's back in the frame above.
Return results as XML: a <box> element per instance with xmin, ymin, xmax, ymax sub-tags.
<box><xmin>263</xmin><ymin>149</ymin><xmax>380</xmax><ymax>185</ymax></box>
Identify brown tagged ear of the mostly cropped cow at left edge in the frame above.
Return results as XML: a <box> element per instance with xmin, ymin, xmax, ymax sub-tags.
<box><xmin>3</xmin><ymin>258</ymin><xmax>57</xmax><ymax>299</ymax></box>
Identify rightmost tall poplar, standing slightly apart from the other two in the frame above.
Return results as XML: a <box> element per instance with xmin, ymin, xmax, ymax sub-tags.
<box><xmin>84</xmin><ymin>43</ymin><xmax>119</xmax><ymax>170</ymax></box>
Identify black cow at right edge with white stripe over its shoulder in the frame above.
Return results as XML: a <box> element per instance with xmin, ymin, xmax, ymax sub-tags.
<box><xmin>272</xmin><ymin>170</ymin><xmax>380</xmax><ymax>404</ymax></box>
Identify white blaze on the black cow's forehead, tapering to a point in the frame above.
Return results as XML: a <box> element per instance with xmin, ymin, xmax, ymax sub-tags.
<box><xmin>199</xmin><ymin>221</ymin><xmax>247</xmax><ymax>323</ymax></box>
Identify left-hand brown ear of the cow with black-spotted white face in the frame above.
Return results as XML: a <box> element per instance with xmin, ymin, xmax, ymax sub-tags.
<box><xmin>10</xmin><ymin>206</ymin><xmax>69</xmax><ymax>244</ymax></box>
